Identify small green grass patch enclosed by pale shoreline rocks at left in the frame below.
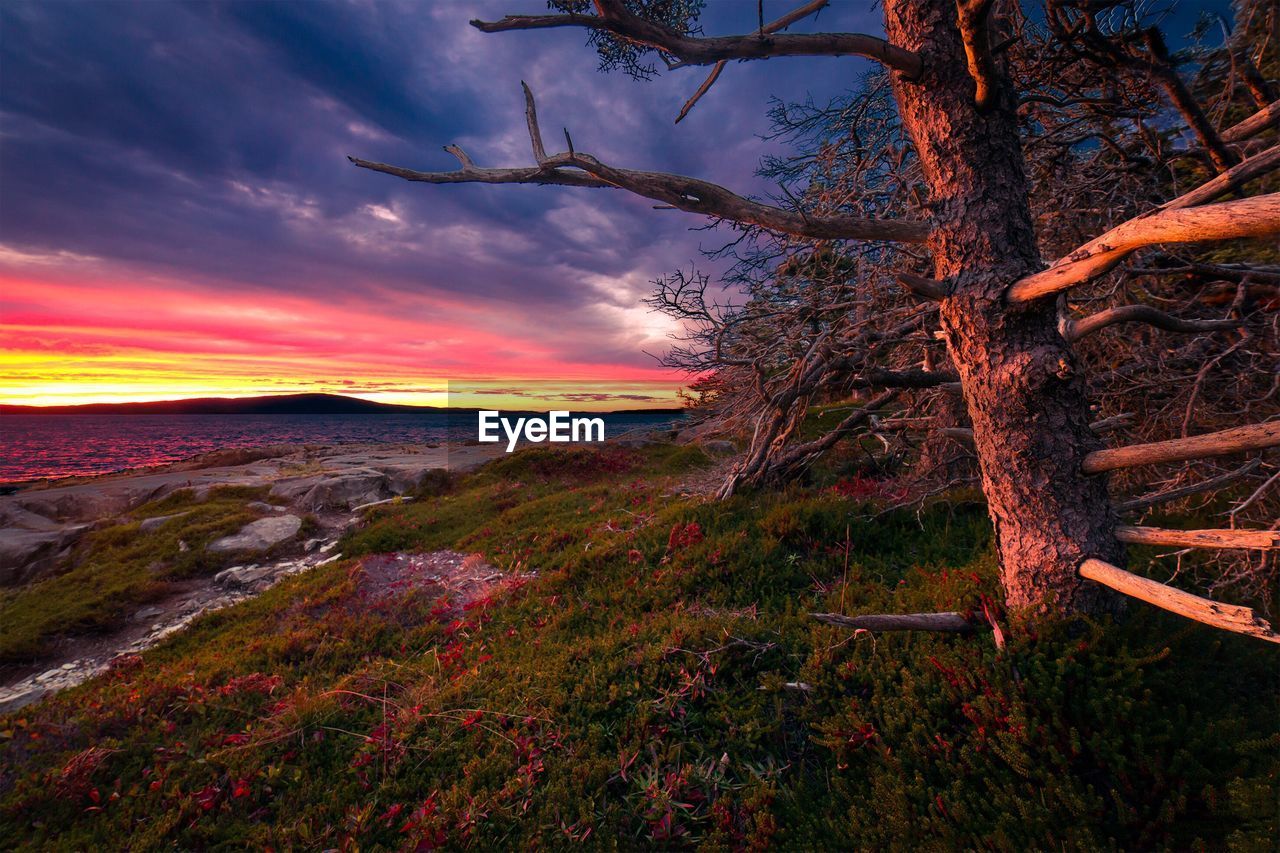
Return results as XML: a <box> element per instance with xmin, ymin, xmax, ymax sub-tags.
<box><xmin>0</xmin><ymin>487</ymin><xmax>277</xmax><ymax>663</ymax></box>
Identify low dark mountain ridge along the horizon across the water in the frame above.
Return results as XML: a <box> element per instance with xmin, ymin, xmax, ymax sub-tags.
<box><xmin>0</xmin><ymin>394</ymin><xmax>682</xmax><ymax>415</ymax></box>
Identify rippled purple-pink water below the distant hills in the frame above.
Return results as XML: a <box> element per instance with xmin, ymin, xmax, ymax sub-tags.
<box><xmin>0</xmin><ymin>412</ymin><xmax>678</xmax><ymax>482</ymax></box>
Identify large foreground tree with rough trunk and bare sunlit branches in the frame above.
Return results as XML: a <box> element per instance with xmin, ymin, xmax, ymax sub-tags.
<box><xmin>353</xmin><ymin>0</ymin><xmax>1280</xmax><ymax>640</ymax></box>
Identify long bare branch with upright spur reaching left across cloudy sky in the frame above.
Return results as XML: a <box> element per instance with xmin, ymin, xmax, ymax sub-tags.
<box><xmin>347</xmin><ymin>86</ymin><xmax>929</xmax><ymax>242</ymax></box>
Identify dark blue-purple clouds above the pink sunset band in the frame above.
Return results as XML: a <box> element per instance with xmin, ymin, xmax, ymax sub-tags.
<box><xmin>0</xmin><ymin>0</ymin><xmax>876</xmax><ymax>364</ymax></box>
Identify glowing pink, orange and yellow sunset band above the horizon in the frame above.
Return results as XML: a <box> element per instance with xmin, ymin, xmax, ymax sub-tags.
<box><xmin>0</xmin><ymin>266</ymin><xmax>681</xmax><ymax>411</ymax></box>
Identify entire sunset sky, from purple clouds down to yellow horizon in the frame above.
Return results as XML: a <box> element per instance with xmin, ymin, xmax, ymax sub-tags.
<box><xmin>0</xmin><ymin>0</ymin><xmax>879</xmax><ymax>409</ymax></box>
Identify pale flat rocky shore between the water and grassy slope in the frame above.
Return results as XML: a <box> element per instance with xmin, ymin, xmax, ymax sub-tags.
<box><xmin>0</xmin><ymin>444</ymin><xmax>500</xmax><ymax>712</ymax></box>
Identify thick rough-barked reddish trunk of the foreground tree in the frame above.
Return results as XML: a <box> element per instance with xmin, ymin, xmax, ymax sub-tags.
<box><xmin>884</xmin><ymin>0</ymin><xmax>1120</xmax><ymax>613</ymax></box>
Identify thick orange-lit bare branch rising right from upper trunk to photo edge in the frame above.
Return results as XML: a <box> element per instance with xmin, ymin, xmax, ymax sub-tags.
<box><xmin>1007</xmin><ymin>193</ymin><xmax>1280</xmax><ymax>302</ymax></box>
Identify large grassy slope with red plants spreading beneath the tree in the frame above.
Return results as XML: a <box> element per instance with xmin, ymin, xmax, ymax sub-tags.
<box><xmin>0</xmin><ymin>447</ymin><xmax>1280</xmax><ymax>850</ymax></box>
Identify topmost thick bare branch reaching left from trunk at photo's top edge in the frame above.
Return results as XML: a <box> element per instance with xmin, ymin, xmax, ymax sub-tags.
<box><xmin>471</xmin><ymin>0</ymin><xmax>920</xmax><ymax>78</ymax></box>
